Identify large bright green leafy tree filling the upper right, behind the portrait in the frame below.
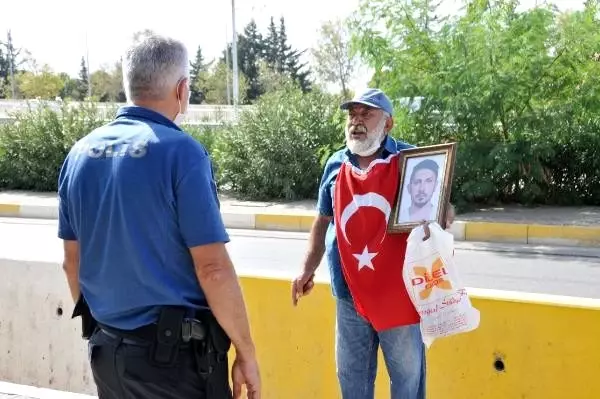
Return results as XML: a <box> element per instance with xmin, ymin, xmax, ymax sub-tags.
<box><xmin>352</xmin><ymin>0</ymin><xmax>600</xmax><ymax>204</ymax></box>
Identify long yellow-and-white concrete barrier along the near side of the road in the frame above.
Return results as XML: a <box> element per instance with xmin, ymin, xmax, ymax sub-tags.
<box><xmin>0</xmin><ymin>260</ymin><xmax>600</xmax><ymax>399</ymax></box>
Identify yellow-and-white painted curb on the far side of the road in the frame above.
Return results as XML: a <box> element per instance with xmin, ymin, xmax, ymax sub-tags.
<box><xmin>0</xmin><ymin>203</ymin><xmax>600</xmax><ymax>247</ymax></box>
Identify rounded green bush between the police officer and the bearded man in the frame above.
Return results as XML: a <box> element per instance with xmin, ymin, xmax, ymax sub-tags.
<box><xmin>213</xmin><ymin>84</ymin><xmax>343</xmax><ymax>200</ymax></box>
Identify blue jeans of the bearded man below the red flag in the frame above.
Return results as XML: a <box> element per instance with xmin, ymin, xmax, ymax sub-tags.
<box><xmin>335</xmin><ymin>298</ymin><xmax>426</xmax><ymax>399</ymax></box>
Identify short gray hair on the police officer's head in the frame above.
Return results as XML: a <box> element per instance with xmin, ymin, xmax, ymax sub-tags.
<box><xmin>123</xmin><ymin>34</ymin><xmax>189</xmax><ymax>102</ymax></box>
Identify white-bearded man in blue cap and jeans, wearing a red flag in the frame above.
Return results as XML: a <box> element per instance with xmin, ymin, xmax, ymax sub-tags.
<box><xmin>292</xmin><ymin>89</ymin><xmax>452</xmax><ymax>399</ymax></box>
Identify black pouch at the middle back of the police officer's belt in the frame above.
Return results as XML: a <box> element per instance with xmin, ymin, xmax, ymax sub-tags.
<box><xmin>150</xmin><ymin>306</ymin><xmax>186</xmax><ymax>367</ymax></box>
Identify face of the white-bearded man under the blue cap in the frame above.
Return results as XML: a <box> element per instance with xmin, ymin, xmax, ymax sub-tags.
<box><xmin>346</xmin><ymin>104</ymin><xmax>386</xmax><ymax>154</ymax></box>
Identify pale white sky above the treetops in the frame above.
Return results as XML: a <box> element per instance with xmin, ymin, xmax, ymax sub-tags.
<box><xmin>0</xmin><ymin>0</ymin><xmax>583</xmax><ymax>90</ymax></box>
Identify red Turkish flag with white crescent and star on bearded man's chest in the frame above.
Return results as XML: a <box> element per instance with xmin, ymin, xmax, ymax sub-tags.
<box><xmin>334</xmin><ymin>154</ymin><xmax>420</xmax><ymax>331</ymax></box>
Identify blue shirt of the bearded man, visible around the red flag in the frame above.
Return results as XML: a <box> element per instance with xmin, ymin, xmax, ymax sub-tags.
<box><xmin>317</xmin><ymin>135</ymin><xmax>414</xmax><ymax>299</ymax></box>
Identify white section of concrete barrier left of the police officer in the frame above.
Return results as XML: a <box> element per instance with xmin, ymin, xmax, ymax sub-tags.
<box><xmin>0</xmin><ymin>260</ymin><xmax>96</xmax><ymax>394</ymax></box>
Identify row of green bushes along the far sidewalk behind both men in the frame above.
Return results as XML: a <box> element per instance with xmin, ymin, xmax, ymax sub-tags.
<box><xmin>0</xmin><ymin>94</ymin><xmax>600</xmax><ymax>210</ymax></box>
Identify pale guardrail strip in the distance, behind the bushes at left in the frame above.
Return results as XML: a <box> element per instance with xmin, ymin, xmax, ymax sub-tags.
<box><xmin>0</xmin><ymin>100</ymin><xmax>251</xmax><ymax>125</ymax></box>
